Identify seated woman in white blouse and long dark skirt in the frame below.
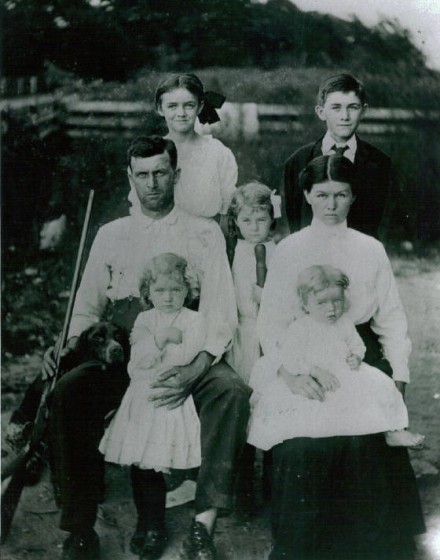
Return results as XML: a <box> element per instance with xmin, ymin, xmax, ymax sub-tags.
<box><xmin>251</xmin><ymin>156</ymin><xmax>424</xmax><ymax>560</ymax></box>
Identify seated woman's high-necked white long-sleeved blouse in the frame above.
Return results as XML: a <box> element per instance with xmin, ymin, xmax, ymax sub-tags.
<box><xmin>257</xmin><ymin>220</ymin><xmax>411</xmax><ymax>382</ymax></box>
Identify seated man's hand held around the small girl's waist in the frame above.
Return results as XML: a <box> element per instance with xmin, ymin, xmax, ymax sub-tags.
<box><xmin>150</xmin><ymin>352</ymin><xmax>214</xmax><ymax>410</ymax></box>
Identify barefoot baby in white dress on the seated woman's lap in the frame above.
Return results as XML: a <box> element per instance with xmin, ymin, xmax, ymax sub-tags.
<box><xmin>248</xmin><ymin>266</ymin><xmax>424</xmax><ymax>449</ymax></box>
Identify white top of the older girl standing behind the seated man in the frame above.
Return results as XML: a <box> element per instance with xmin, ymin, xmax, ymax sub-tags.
<box><xmin>174</xmin><ymin>136</ymin><xmax>237</xmax><ymax>218</ymax></box>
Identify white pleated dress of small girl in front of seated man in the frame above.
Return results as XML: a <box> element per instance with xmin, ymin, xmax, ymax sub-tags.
<box><xmin>99</xmin><ymin>307</ymin><xmax>205</xmax><ymax>472</ymax></box>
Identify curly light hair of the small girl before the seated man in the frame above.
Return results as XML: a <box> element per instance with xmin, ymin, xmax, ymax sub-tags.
<box><xmin>139</xmin><ymin>253</ymin><xmax>200</xmax><ymax>309</ymax></box>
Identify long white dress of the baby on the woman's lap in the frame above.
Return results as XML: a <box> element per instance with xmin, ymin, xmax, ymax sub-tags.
<box><xmin>248</xmin><ymin>316</ymin><xmax>408</xmax><ymax>450</ymax></box>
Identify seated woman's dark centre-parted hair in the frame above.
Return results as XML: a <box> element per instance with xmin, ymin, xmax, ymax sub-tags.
<box><xmin>299</xmin><ymin>155</ymin><xmax>357</xmax><ymax>195</ymax></box>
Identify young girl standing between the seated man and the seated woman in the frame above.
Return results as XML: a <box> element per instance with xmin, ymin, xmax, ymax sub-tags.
<box><xmin>227</xmin><ymin>182</ymin><xmax>275</xmax><ymax>383</ymax></box>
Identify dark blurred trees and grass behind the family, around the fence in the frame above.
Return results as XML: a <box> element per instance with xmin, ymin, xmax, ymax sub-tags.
<box><xmin>2</xmin><ymin>0</ymin><xmax>440</xmax><ymax>359</ymax></box>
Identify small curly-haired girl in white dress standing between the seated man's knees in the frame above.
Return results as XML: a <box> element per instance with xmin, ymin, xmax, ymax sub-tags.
<box><xmin>99</xmin><ymin>253</ymin><xmax>204</xmax><ymax>554</ymax></box>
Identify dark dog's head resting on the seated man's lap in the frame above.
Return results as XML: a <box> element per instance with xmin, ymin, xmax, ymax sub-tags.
<box><xmin>75</xmin><ymin>321</ymin><xmax>130</xmax><ymax>365</ymax></box>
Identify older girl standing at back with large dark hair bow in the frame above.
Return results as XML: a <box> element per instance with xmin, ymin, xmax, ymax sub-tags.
<box><xmin>129</xmin><ymin>74</ymin><xmax>237</xmax><ymax>221</ymax></box>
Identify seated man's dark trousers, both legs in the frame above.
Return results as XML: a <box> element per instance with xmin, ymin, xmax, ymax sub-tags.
<box><xmin>49</xmin><ymin>352</ymin><xmax>250</xmax><ymax>532</ymax></box>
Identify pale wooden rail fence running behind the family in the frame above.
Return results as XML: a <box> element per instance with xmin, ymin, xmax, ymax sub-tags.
<box><xmin>0</xmin><ymin>95</ymin><xmax>440</xmax><ymax>140</ymax></box>
